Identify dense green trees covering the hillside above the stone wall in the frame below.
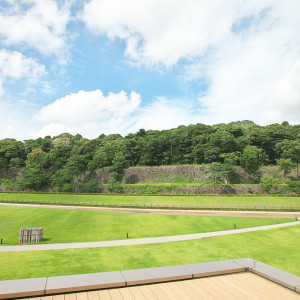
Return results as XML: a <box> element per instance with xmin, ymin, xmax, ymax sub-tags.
<box><xmin>0</xmin><ymin>120</ymin><xmax>300</xmax><ymax>192</ymax></box>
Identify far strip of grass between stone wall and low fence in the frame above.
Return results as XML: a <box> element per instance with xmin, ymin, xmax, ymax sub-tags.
<box><xmin>0</xmin><ymin>193</ymin><xmax>300</xmax><ymax>208</ymax></box>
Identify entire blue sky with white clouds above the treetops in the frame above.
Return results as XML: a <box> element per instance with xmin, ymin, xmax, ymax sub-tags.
<box><xmin>0</xmin><ymin>0</ymin><xmax>300</xmax><ymax>140</ymax></box>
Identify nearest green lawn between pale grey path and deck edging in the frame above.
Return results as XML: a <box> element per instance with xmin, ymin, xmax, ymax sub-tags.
<box><xmin>0</xmin><ymin>226</ymin><xmax>300</xmax><ymax>280</ymax></box>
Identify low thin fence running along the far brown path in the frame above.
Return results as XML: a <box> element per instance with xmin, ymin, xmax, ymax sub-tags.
<box><xmin>0</xmin><ymin>199</ymin><xmax>300</xmax><ymax>212</ymax></box>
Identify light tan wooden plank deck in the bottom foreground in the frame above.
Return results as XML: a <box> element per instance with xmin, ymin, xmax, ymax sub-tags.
<box><xmin>22</xmin><ymin>272</ymin><xmax>300</xmax><ymax>300</ymax></box>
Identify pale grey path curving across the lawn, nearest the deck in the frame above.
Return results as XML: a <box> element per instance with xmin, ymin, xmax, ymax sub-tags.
<box><xmin>0</xmin><ymin>221</ymin><xmax>300</xmax><ymax>252</ymax></box>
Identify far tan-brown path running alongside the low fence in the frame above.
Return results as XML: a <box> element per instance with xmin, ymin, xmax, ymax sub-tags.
<box><xmin>0</xmin><ymin>203</ymin><xmax>300</xmax><ymax>219</ymax></box>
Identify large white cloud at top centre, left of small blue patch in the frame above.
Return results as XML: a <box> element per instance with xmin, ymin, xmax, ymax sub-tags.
<box><xmin>81</xmin><ymin>0</ymin><xmax>236</xmax><ymax>66</ymax></box>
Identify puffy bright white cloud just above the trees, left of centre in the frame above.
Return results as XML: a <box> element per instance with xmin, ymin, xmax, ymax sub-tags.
<box><xmin>36</xmin><ymin>90</ymin><xmax>141</xmax><ymax>137</ymax></box>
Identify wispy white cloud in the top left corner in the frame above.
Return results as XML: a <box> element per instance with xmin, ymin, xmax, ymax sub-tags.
<box><xmin>0</xmin><ymin>0</ymin><xmax>70</xmax><ymax>56</ymax></box>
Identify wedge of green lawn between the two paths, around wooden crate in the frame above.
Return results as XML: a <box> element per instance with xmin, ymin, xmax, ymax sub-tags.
<box><xmin>0</xmin><ymin>206</ymin><xmax>294</xmax><ymax>245</ymax></box>
